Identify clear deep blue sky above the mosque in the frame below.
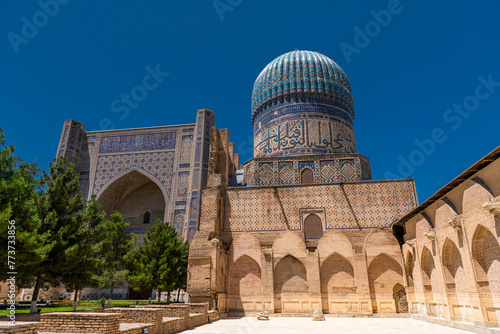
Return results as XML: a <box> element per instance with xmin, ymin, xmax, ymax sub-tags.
<box><xmin>0</xmin><ymin>0</ymin><xmax>500</xmax><ymax>202</ymax></box>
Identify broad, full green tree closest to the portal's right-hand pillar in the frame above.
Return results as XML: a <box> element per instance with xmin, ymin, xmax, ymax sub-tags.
<box><xmin>128</xmin><ymin>220</ymin><xmax>189</xmax><ymax>303</ymax></box>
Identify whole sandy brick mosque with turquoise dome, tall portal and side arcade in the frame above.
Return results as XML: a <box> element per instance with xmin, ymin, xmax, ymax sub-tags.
<box><xmin>4</xmin><ymin>51</ymin><xmax>500</xmax><ymax>329</ymax></box>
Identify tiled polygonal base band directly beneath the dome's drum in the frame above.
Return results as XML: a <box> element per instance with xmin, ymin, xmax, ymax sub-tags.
<box><xmin>243</xmin><ymin>154</ymin><xmax>371</xmax><ymax>186</ymax></box>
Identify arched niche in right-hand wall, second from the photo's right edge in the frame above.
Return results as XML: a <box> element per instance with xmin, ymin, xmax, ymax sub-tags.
<box><xmin>442</xmin><ymin>238</ymin><xmax>467</xmax><ymax>292</ymax></box>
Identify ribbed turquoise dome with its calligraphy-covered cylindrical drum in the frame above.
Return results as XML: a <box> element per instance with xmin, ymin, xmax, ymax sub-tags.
<box><xmin>252</xmin><ymin>51</ymin><xmax>356</xmax><ymax>158</ymax></box>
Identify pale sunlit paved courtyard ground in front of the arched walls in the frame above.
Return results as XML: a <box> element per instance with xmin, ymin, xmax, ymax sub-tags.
<box><xmin>181</xmin><ymin>317</ymin><xmax>471</xmax><ymax>334</ymax></box>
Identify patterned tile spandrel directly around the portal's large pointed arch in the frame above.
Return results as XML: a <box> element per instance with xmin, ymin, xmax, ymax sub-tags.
<box><xmin>92</xmin><ymin>152</ymin><xmax>174</xmax><ymax>200</ymax></box>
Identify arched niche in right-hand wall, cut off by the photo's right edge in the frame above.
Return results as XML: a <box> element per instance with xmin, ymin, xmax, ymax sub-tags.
<box><xmin>472</xmin><ymin>225</ymin><xmax>500</xmax><ymax>293</ymax></box>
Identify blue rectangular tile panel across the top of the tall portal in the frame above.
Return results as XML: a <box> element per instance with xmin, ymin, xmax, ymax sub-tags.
<box><xmin>99</xmin><ymin>132</ymin><xmax>175</xmax><ymax>153</ymax></box>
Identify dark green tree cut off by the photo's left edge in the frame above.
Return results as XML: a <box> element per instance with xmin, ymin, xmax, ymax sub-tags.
<box><xmin>0</xmin><ymin>128</ymin><xmax>52</xmax><ymax>310</ymax></box>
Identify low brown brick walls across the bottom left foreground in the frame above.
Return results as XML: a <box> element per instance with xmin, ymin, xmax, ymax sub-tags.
<box><xmin>0</xmin><ymin>304</ymin><xmax>216</xmax><ymax>334</ymax></box>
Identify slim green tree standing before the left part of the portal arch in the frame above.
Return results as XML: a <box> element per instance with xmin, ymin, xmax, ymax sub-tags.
<box><xmin>94</xmin><ymin>211</ymin><xmax>137</xmax><ymax>307</ymax></box>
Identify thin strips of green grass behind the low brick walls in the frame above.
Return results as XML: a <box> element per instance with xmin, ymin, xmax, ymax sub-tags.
<box><xmin>0</xmin><ymin>300</ymin><xmax>152</xmax><ymax>316</ymax></box>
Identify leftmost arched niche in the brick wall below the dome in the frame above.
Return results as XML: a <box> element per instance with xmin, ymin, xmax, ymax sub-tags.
<box><xmin>228</xmin><ymin>255</ymin><xmax>262</xmax><ymax>311</ymax></box>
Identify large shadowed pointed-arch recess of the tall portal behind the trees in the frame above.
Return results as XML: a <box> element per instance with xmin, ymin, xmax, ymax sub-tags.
<box><xmin>99</xmin><ymin>170</ymin><xmax>165</xmax><ymax>243</ymax></box>
